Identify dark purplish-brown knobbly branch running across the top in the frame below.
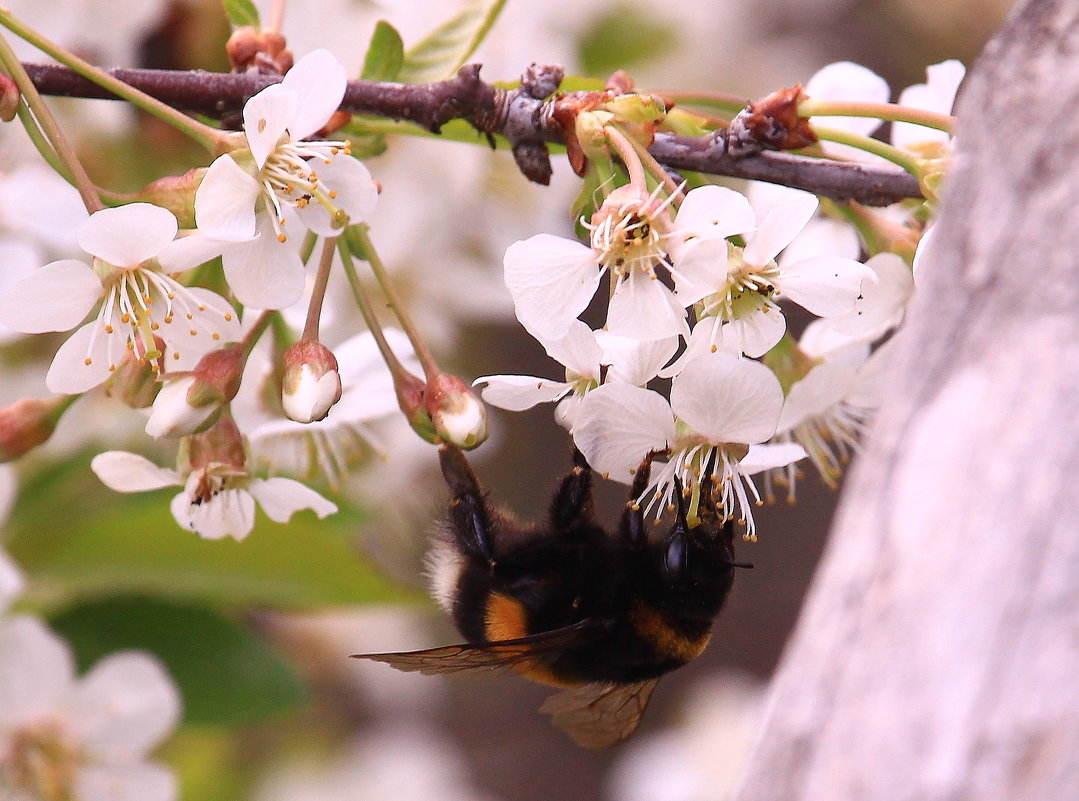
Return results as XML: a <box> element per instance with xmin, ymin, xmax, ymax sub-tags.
<box><xmin>26</xmin><ymin>64</ymin><xmax>921</xmax><ymax>206</ymax></box>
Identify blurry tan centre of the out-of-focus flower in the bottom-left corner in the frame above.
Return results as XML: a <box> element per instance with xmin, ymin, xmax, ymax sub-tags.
<box><xmin>0</xmin><ymin>721</ymin><xmax>83</xmax><ymax>801</ymax></box>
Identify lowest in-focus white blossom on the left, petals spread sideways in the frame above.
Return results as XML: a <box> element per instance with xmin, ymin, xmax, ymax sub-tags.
<box><xmin>91</xmin><ymin>450</ymin><xmax>337</xmax><ymax>540</ymax></box>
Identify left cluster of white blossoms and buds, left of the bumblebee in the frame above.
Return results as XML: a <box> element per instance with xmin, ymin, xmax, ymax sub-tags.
<box><xmin>0</xmin><ymin>51</ymin><xmax>442</xmax><ymax>539</ymax></box>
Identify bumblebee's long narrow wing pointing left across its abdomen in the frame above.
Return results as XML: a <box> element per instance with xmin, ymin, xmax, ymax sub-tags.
<box><xmin>353</xmin><ymin>620</ymin><xmax>592</xmax><ymax>676</ymax></box>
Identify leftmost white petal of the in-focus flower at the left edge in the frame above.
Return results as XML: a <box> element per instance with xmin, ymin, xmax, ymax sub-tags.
<box><xmin>0</xmin><ymin>259</ymin><xmax>103</xmax><ymax>334</ymax></box>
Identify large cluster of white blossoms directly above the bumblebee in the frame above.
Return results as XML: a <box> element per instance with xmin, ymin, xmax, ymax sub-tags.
<box><xmin>477</xmin><ymin>56</ymin><xmax>961</xmax><ymax>539</ymax></box>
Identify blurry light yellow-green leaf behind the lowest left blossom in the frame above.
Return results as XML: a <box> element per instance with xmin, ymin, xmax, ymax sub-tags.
<box><xmin>5</xmin><ymin>456</ymin><xmax>418</xmax><ymax>609</ymax></box>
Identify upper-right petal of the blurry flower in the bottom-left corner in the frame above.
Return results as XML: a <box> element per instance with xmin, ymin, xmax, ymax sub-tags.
<box><xmin>67</xmin><ymin>651</ymin><xmax>180</xmax><ymax>761</ymax></box>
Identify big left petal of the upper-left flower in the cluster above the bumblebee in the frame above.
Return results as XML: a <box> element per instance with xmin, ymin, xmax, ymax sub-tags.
<box><xmin>503</xmin><ymin>233</ymin><xmax>602</xmax><ymax>340</ymax></box>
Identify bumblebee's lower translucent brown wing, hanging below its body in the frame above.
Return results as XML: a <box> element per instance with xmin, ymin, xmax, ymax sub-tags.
<box><xmin>540</xmin><ymin>679</ymin><xmax>658</xmax><ymax>748</ymax></box>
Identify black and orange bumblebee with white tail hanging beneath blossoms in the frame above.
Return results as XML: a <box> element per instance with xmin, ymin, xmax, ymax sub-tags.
<box><xmin>355</xmin><ymin>445</ymin><xmax>752</xmax><ymax>748</ymax></box>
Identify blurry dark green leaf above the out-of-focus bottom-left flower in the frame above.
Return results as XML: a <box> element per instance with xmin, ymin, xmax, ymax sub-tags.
<box><xmin>51</xmin><ymin>597</ymin><xmax>306</xmax><ymax>725</ymax></box>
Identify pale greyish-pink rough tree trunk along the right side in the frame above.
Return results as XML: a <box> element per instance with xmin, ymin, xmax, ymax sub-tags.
<box><xmin>738</xmin><ymin>0</ymin><xmax>1079</xmax><ymax>801</ymax></box>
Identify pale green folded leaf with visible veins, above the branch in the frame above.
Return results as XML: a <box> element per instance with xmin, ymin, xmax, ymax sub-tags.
<box><xmin>398</xmin><ymin>0</ymin><xmax>506</xmax><ymax>83</ymax></box>
